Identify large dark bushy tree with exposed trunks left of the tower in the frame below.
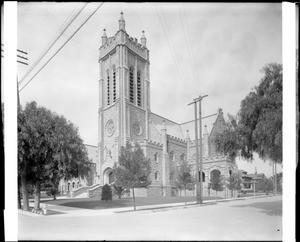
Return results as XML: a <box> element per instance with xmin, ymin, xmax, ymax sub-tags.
<box><xmin>18</xmin><ymin>102</ymin><xmax>90</xmax><ymax>209</ymax></box>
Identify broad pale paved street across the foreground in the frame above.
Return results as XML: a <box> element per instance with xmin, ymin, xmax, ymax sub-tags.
<box><xmin>19</xmin><ymin>196</ymin><xmax>282</xmax><ymax>240</ymax></box>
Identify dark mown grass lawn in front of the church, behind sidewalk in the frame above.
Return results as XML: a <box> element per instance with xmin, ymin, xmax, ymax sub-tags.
<box><xmin>43</xmin><ymin>197</ymin><xmax>220</xmax><ymax>210</ymax></box>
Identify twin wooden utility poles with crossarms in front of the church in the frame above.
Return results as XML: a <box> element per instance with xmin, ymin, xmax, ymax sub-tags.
<box><xmin>188</xmin><ymin>95</ymin><xmax>207</xmax><ymax>204</ymax></box>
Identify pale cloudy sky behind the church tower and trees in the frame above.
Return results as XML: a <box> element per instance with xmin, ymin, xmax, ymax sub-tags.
<box><xmin>17</xmin><ymin>2</ymin><xmax>282</xmax><ymax>176</ymax></box>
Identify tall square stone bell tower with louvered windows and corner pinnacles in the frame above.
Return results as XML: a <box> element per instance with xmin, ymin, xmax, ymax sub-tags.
<box><xmin>97</xmin><ymin>12</ymin><xmax>150</xmax><ymax>184</ymax></box>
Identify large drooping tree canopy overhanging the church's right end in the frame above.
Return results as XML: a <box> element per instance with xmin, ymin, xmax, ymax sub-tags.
<box><xmin>215</xmin><ymin>63</ymin><xmax>282</xmax><ymax>163</ymax></box>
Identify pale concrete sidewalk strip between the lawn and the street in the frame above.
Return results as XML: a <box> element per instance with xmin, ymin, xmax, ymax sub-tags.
<box><xmin>18</xmin><ymin>195</ymin><xmax>273</xmax><ymax>217</ymax></box>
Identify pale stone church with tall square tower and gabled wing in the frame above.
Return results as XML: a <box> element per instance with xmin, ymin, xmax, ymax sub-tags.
<box><xmin>94</xmin><ymin>14</ymin><xmax>236</xmax><ymax>196</ymax></box>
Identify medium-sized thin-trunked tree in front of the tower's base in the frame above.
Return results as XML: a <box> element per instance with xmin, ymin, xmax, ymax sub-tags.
<box><xmin>113</xmin><ymin>142</ymin><xmax>151</xmax><ymax>210</ymax></box>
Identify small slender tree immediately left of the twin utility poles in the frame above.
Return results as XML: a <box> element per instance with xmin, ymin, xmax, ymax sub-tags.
<box><xmin>176</xmin><ymin>161</ymin><xmax>195</xmax><ymax>204</ymax></box>
